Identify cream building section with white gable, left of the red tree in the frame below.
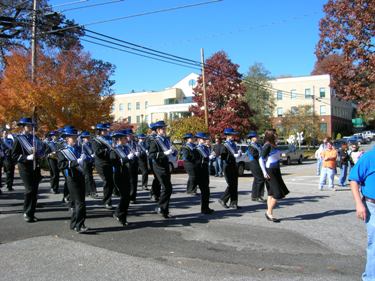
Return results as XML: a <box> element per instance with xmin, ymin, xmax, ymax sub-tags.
<box><xmin>112</xmin><ymin>73</ymin><xmax>198</xmax><ymax>124</ymax></box>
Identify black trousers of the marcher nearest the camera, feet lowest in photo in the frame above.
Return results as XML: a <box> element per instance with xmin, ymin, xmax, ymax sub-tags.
<box><xmin>66</xmin><ymin>173</ymin><xmax>86</xmax><ymax>230</ymax></box>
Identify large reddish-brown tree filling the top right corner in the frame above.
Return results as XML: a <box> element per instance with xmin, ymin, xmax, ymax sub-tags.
<box><xmin>316</xmin><ymin>0</ymin><xmax>375</xmax><ymax>117</ymax></box>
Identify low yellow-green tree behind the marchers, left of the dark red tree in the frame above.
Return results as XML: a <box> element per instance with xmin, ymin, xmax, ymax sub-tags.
<box><xmin>168</xmin><ymin>116</ymin><xmax>207</xmax><ymax>140</ymax></box>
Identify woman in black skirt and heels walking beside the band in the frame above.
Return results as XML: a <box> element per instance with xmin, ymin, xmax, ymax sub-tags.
<box><xmin>259</xmin><ymin>130</ymin><xmax>289</xmax><ymax>222</ymax></box>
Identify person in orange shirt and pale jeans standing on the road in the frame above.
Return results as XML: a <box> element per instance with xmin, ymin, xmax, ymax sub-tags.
<box><xmin>319</xmin><ymin>141</ymin><xmax>337</xmax><ymax>190</ymax></box>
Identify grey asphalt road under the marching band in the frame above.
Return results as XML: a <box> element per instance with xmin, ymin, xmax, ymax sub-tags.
<box><xmin>0</xmin><ymin>143</ymin><xmax>374</xmax><ymax>281</ymax></box>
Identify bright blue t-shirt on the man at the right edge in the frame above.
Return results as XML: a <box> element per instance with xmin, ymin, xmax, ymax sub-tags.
<box><xmin>349</xmin><ymin>147</ymin><xmax>375</xmax><ymax>199</ymax></box>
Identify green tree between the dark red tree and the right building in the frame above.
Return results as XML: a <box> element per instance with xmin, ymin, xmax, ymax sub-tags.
<box><xmin>244</xmin><ymin>63</ymin><xmax>275</xmax><ymax>132</ymax></box>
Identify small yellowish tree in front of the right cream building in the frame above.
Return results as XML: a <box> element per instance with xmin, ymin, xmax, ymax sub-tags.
<box><xmin>281</xmin><ymin>105</ymin><xmax>324</xmax><ymax>142</ymax></box>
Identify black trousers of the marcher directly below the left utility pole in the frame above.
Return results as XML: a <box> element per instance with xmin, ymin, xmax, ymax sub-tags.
<box><xmin>18</xmin><ymin>161</ymin><xmax>41</xmax><ymax>218</ymax></box>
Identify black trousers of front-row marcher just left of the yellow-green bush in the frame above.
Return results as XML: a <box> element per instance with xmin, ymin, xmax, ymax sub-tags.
<box><xmin>153</xmin><ymin>163</ymin><xmax>172</xmax><ymax>214</ymax></box>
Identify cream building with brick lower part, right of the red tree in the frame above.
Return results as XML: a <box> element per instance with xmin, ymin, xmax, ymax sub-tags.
<box><xmin>270</xmin><ymin>74</ymin><xmax>354</xmax><ymax>137</ymax></box>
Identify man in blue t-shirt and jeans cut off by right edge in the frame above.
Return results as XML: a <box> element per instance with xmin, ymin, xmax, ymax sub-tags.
<box><xmin>349</xmin><ymin>145</ymin><xmax>375</xmax><ymax>281</ymax></box>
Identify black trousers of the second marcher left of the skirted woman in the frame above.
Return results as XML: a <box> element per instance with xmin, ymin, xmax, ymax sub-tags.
<box><xmin>221</xmin><ymin>162</ymin><xmax>238</xmax><ymax>205</ymax></box>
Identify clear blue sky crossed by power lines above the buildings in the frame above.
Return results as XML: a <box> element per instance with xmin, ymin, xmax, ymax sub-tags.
<box><xmin>50</xmin><ymin>0</ymin><xmax>326</xmax><ymax>94</ymax></box>
